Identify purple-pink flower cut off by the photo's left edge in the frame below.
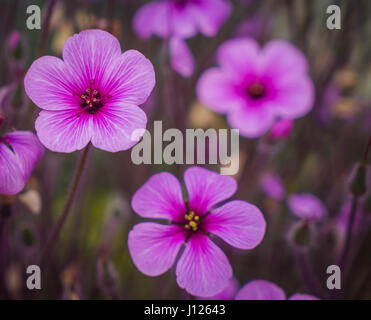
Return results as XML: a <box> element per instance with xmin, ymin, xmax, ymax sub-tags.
<box><xmin>0</xmin><ymin>131</ymin><xmax>44</xmax><ymax>195</ymax></box>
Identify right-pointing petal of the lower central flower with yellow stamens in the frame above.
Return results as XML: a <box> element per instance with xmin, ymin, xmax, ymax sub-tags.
<box><xmin>202</xmin><ymin>200</ymin><xmax>266</xmax><ymax>249</ymax></box>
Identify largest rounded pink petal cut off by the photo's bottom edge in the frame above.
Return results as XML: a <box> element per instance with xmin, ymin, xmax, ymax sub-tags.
<box><xmin>236</xmin><ymin>280</ymin><xmax>286</xmax><ymax>300</ymax></box>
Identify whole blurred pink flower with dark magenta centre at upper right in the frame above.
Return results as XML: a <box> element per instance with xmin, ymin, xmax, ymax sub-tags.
<box><xmin>197</xmin><ymin>38</ymin><xmax>314</xmax><ymax>138</ymax></box>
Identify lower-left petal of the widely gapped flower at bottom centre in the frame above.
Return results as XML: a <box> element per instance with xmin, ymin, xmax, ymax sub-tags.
<box><xmin>128</xmin><ymin>222</ymin><xmax>186</xmax><ymax>276</ymax></box>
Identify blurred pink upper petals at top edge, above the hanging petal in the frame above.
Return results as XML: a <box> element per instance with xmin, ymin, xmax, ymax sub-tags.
<box><xmin>133</xmin><ymin>0</ymin><xmax>231</xmax><ymax>39</ymax></box>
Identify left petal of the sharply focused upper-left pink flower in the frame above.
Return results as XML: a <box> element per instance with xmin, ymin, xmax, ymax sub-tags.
<box><xmin>24</xmin><ymin>56</ymin><xmax>81</xmax><ymax>110</ymax></box>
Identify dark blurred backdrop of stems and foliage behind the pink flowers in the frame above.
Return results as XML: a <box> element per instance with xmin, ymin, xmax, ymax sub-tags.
<box><xmin>0</xmin><ymin>0</ymin><xmax>371</xmax><ymax>299</ymax></box>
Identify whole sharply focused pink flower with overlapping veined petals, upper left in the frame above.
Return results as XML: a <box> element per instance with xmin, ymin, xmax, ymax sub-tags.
<box><xmin>24</xmin><ymin>30</ymin><xmax>155</xmax><ymax>152</ymax></box>
